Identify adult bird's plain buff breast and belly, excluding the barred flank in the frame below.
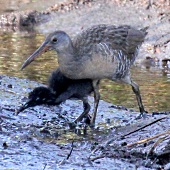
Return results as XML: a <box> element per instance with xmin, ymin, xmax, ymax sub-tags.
<box><xmin>59</xmin><ymin>54</ymin><xmax>117</xmax><ymax>79</ymax></box>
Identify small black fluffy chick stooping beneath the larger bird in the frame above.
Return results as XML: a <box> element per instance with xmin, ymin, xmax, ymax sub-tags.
<box><xmin>17</xmin><ymin>69</ymin><xmax>95</xmax><ymax>123</ymax></box>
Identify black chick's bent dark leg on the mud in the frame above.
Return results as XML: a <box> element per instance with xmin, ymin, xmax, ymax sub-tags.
<box><xmin>74</xmin><ymin>97</ymin><xmax>90</xmax><ymax>123</ymax></box>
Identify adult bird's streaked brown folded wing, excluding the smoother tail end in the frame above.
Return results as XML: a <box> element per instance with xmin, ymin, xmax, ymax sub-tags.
<box><xmin>73</xmin><ymin>25</ymin><xmax>129</xmax><ymax>56</ymax></box>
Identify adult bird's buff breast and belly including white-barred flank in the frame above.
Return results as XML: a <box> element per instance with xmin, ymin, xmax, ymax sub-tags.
<box><xmin>59</xmin><ymin>44</ymin><xmax>131</xmax><ymax>79</ymax></box>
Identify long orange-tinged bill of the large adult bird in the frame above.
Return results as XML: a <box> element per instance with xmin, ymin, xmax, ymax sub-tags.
<box><xmin>21</xmin><ymin>41</ymin><xmax>50</xmax><ymax>70</ymax></box>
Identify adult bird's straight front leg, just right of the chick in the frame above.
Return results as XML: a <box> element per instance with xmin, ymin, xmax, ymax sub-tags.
<box><xmin>91</xmin><ymin>80</ymin><xmax>100</xmax><ymax>127</ymax></box>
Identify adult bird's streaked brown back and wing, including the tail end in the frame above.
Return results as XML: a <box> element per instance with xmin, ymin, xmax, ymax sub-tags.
<box><xmin>73</xmin><ymin>25</ymin><xmax>146</xmax><ymax>61</ymax></box>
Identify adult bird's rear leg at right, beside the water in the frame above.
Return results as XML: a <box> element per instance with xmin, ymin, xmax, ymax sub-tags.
<box><xmin>131</xmin><ymin>80</ymin><xmax>146</xmax><ymax>118</ymax></box>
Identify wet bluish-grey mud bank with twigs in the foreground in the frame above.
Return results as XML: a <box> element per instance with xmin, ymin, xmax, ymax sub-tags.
<box><xmin>0</xmin><ymin>76</ymin><xmax>170</xmax><ymax>170</ymax></box>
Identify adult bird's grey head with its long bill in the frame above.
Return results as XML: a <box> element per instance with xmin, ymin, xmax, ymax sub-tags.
<box><xmin>21</xmin><ymin>31</ymin><xmax>72</xmax><ymax>70</ymax></box>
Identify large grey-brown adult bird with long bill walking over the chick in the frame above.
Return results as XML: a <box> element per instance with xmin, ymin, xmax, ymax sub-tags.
<box><xmin>21</xmin><ymin>25</ymin><xmax>147</xmax><ymax>124</ymax></box>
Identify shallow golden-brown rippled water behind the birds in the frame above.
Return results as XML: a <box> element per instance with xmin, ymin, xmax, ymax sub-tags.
<box><xmin>0</xmin><ymin>33</ymin><xmax>170</xmax><ymax>112</ymax></box>
